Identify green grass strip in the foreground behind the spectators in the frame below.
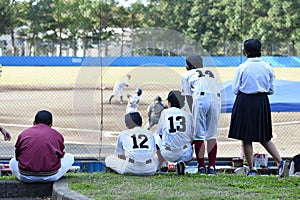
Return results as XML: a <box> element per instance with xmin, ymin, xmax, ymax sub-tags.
<box><xmin>65</xmin><ymin>172</ymin><xmax>300</xmax><ymax>199</ymax></box>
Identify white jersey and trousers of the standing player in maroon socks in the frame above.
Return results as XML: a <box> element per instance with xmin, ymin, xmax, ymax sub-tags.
<box><xmin>181</xmin><ymin>68</ymin><xmax>221</xmax><ymax>140</ymax></box>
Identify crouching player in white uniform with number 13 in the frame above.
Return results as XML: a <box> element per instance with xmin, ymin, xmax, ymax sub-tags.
<box><xmin>156</xmin><ymin>90</ymin><xmax>193</xmax><ymax>175</ymax></box>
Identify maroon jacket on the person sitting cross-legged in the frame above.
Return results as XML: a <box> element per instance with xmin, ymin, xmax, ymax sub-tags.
<box><xmin>15</xmin><ymin>124</ymin><xmax>65</xmax><ymax>175</ymax></box>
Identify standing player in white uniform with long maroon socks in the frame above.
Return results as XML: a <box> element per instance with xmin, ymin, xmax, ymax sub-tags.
<box><xmin>182</xmin><ymin>55</ymin><xmax>221</xmax><ymax>175</ymax></box>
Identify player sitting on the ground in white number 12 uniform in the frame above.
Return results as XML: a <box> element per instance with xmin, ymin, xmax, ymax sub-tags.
<box><xmin>105</xmin><ymin>112</ymin><xmax>158</xmax><ymax>176</ymax></box>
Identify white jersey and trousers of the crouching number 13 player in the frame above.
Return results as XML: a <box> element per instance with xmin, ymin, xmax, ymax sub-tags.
<box><xmin>156</xmin><ymin>107</ymin><xmax>193</xmax><ymax>162</ymax></box>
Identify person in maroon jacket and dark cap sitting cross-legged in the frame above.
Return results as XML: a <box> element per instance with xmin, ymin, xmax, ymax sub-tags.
<box><xmin>9</xmin><ymin>110</ymin><xmax>74</xmax><ymax>183</ymax></box>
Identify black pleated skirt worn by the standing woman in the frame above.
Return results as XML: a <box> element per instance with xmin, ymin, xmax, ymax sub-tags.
<box><xmin>228</xmin><ymin>92</ymin><xmax>273</xmax><ymax>142</ymax></box>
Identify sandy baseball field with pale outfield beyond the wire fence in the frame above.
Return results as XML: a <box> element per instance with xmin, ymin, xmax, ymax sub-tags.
<box><xmin>0</xmin><ymin>66</ymin><xmax>300</xmax><ymax>159</ymax></box>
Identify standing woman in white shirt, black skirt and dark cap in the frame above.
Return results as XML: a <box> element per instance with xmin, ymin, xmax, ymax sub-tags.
<box><xmin>228</xmin><ymin>39</ymin><xmax>287</xmax><ymax>176</ymax></box>
